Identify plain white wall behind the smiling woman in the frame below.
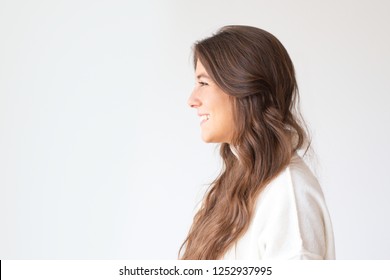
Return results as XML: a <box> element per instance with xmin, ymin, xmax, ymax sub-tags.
<box><xmin>0</xmin><ymin>0</ymin><xmax>390</xmax><ymax>259</ymax></box>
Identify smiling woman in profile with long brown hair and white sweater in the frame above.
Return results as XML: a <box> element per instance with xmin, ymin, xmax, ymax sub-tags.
<box><xmin>180</xmin><ymin>26</ymin><xmax>335</xmax><ymax>259</ymax></box>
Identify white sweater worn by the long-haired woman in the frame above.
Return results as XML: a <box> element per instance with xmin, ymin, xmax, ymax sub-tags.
<box><xmin>223</xmin><ymin>155</ymin><xmax>335</xmax><ymax>260</ymax></box>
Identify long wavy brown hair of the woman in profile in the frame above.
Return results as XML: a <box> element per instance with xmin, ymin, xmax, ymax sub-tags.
<box><xmin>179</xmin><ymin>26</ymin><xmax>309</xmax><ymax>260</ymax></box>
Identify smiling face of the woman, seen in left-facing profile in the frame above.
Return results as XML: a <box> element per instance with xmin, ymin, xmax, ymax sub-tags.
<box><xmin>188</xmin><ymin>60</ymin><xmax>234</xmax><ymax>143</ymax></box>
